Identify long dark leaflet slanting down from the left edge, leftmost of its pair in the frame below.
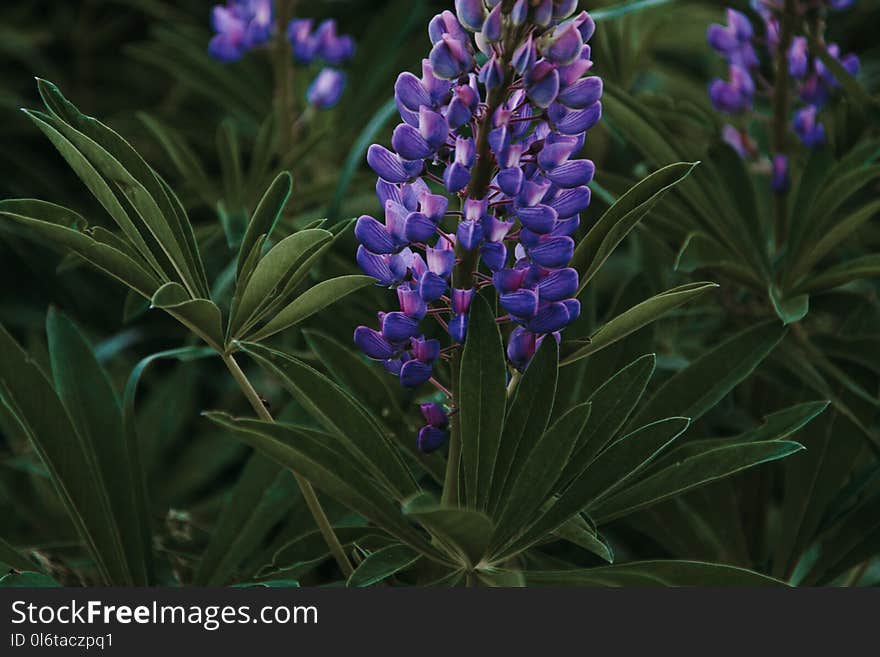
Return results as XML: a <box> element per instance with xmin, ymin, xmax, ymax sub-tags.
<box><xmin>0</xmin><ymin>326</ymin><xmax>133</xmax><ymax>585</ymax></box>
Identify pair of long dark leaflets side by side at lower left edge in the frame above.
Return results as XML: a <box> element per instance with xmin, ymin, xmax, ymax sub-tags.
<box><xmin>0</xmin><ymin>315</ymin><xmax>147</xmax><ymax>586</ymax></box>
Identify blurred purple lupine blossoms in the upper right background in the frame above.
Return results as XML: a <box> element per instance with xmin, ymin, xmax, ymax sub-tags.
<box><xmin>707</xmin><ymin>0</ymin><xmax>859</xmax><ymax>191</ymax></box>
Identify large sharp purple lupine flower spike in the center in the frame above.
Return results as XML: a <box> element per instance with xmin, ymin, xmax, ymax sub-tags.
<box><xmin>354</xmin><ymin>0</ymin><xmax>602</xmax><ymax>451</ymax></box>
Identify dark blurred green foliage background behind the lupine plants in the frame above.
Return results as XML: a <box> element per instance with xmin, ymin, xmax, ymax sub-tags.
<box><xmin>0</xmin><ymin>0</ymin><xmax>880</xmax><ymax>584</ymax></box>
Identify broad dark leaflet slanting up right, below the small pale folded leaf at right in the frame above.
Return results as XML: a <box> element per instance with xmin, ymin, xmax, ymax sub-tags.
<box><xmin>630</xmin><ymin>321</ymin><xmax>786</xmax><ymax>427</ymax></box>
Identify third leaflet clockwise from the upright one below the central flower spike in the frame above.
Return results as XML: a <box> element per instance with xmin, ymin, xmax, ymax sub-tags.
<box><xmin>492</xmin><ymin>403</ymin><xmax>590</xmax><ymax>545</ymax></box>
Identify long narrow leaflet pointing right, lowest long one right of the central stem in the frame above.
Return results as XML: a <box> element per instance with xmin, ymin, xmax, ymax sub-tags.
<box><xmin>588</xmin><ymin>440</ymin><xmax>804</xmax><ymax>523</ymax></box>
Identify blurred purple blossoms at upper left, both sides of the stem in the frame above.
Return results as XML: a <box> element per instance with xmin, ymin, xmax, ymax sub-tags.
<box><xmin>208</xmin><ymin>0</ymin><xmax>354</xmax><ymax>109</ymax></box>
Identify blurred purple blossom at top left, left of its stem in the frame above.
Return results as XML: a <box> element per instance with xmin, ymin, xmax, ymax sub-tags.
<box><xmin>208</xmin><ymin>0</ymin><xmax>272</xmax><ymax>62</ymax></box>
